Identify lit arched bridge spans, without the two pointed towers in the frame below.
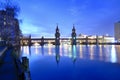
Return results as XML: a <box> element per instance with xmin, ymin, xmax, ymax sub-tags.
<box><xmin>21</xmin><ymin>37</ymin><xmax>116</xmax><ymax>45</ymax></box>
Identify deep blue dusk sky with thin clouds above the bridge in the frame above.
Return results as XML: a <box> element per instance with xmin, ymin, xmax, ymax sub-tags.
<box><xmin>19</xmin><ymin>0</ymin><xmax>120</xmax><ymax>37</ymax></box>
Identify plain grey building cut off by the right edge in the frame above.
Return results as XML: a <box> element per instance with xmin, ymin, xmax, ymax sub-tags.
<box><xmin>114</xmin><ymin>21</ymin><xmax>120</xmax><ymax>41</ymax></box>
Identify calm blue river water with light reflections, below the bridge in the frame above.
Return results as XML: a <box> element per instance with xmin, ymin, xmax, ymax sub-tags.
<box><xmin>21</xmin><ymin>45</ymin><xmax>120</xmax><ymax>80</ymax></box>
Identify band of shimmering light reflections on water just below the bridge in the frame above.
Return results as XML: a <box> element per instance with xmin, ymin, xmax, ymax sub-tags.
<box><xmin>21</xmin><ymin>45</ymin><xmax>120</xmax><ymax>63</ymax></box>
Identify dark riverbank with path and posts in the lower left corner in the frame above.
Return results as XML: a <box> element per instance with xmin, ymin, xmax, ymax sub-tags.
<box><xmin>0</xmin><ymin>47</ymin><xmax>25</xmax><ymax>80</ymax></box>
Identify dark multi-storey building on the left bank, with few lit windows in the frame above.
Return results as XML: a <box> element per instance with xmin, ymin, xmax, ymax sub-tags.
<box><xmin>0</xmin><ymin>7</ymin><xmax>21</xmax><ymax>43</ymax></box>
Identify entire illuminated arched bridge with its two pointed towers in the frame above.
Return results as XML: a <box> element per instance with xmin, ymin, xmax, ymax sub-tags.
<box><xmin>20</xmin><ymin>26</ymin><xmax>119</xmax><ymax>46</ymax></box>
